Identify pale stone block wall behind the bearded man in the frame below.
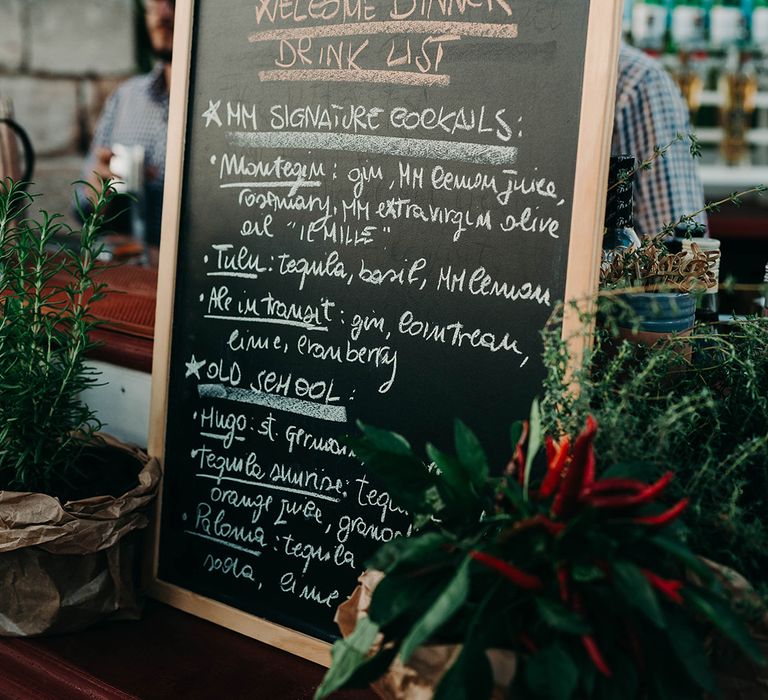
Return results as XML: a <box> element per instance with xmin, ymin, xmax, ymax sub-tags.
<box><xmin>0</xmin><ymin>0</ymin><xmax>136</xmax><ymax>220</ymax></box>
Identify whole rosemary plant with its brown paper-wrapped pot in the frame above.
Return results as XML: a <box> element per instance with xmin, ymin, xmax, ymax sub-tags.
<box><xmin>0</xmin><ymin>179</ymin><xmax>160</xmax><ymax>636</ymax></box>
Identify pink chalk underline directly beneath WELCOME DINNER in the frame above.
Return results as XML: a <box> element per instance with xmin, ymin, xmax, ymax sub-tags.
<box><xmin>248</xmin><ymin>20</ymin><xmax>517</xmax><ymax>43</ymax></box>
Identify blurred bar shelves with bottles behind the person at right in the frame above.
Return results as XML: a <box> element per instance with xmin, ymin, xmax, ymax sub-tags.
<box><xmin>624</xmin><ymin>0</ymin><xmax>768</xmax><ymax>313</ymax></box>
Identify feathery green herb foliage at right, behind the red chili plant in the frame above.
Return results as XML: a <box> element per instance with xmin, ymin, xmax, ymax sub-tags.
<box><xmin>542</xmin><ymin>297</ymin><xmax>768</xmax><ymax>601</ymax></box>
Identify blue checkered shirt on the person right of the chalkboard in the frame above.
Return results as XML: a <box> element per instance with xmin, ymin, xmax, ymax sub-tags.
<box><xmin>611</xmin><ymin>44</ymin><xmax>706</xmax><ymax>241</ymax></box>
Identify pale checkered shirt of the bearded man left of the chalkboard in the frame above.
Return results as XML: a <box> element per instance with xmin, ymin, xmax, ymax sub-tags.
<box><xmin>83</xmin><ymin>63</ymin><xmax>168</xmax><ymax>245</ymax></box>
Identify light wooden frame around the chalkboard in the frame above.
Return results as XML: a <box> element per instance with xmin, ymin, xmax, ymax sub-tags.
<box><xmin>146</xmin><ymin>0</ymin><xmax>622</xmax><ymax>665</ymax></box>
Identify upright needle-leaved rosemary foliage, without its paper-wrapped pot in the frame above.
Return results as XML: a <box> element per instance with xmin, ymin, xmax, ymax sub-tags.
<box><xmin>0</xmin><ymin>179</ymin><xmax>114</xmax><ymax>493</ymax></box>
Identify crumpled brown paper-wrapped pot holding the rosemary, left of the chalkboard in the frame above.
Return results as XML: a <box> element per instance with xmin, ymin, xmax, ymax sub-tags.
<box><xmin>0</xmin><ymin>436</ymin><xmax>160</xmax><ymax>637</ymax></box>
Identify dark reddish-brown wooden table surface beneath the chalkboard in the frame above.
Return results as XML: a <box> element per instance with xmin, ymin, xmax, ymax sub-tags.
<box><xmin>0</xmin><ymin>601</ymin><xmax>376</xmax><ymax>700</ymax></box>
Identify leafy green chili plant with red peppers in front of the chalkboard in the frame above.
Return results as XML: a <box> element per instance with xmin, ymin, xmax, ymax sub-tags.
<box><xmin>317</xmin><ymin>404</ymin><xmax>762</xmax><ymax>700</ymax></box>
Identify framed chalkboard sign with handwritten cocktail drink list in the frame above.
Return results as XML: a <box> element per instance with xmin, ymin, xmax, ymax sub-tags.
<box><xmin>150</xmin><ymin>0</ymin><xmax>620</xmax><ymax>663</ymax></box>
